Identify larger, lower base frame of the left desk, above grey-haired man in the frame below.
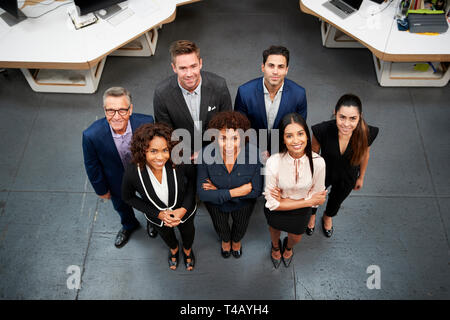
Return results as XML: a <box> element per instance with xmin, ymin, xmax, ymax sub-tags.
<box><xmin>20</xmin><ymin>57</ymin><xmax>106</xmax><ymax>93</ymax></box>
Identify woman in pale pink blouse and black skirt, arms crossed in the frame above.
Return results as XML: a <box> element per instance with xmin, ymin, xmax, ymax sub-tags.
<box><xmin>264</xmin><ymin>113</ymin><xmax>327</xmax><ymax>268</ymax></box>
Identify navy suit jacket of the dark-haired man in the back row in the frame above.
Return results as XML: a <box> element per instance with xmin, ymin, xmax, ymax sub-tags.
<box><xmin>234</xmin><ymin>77</ymin><xmax>307</xmax><ymax>130</ymax></box>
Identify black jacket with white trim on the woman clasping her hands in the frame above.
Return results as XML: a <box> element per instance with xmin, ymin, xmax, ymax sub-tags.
<box><xmin>122</xmin><ymin>162</ymin><xmax>197</xmax><ymax>227</ymax></box>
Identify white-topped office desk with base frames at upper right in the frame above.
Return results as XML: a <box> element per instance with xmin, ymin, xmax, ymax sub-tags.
<box><xmin>300</xmin><ymin>0</ymin><xmax>450</xmax><ymax>86</ymax></box>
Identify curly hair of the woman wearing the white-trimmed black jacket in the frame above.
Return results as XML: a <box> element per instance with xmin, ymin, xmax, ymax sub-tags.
<box><xmin>130</xmin><ymin>123</ymin><xmax>176</xmax><ymax>169</ymax></box>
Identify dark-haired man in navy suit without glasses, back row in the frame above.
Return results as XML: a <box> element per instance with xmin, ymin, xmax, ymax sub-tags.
<box><xmin>234</xmin><ymin>46</ymin><xmax>307</xmax><ymax>156</ymax></box>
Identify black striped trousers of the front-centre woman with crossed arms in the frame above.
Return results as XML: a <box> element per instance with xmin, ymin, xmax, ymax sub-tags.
<box><xmin>205</xmin><ymin>202</ymin><xmax>255</xmax><ymax>242</ymax></box>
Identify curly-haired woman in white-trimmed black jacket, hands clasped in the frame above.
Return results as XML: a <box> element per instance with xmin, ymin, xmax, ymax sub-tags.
<box><xmin>122</xmin><ymin>123</ymin><xmax>197</xmax><ymax>271</ymax></box>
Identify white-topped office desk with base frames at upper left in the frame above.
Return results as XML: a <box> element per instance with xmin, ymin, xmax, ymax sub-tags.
<box><xmin>0</xmin><ymin>0</ymin><xmax>199</xmax><ymax>93</ymax></box>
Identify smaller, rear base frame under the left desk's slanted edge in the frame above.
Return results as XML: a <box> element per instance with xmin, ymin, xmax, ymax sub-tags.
<box><xmin>110</xmin><ymin>27</ymin><xmax>158</xmax><ymax>57</ymax></box>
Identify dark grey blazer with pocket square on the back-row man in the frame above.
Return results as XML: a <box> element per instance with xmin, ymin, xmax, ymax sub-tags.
<box><xmin>153</xmin><ymin>71</ymin><xmax>232</xmax><ymax>151</ymax></box>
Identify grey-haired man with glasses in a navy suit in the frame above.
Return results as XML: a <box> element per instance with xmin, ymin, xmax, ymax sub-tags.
<box><xmin>83</xmin><ymin>87</ymin><xmax>157</xmax><ymax>248</ymax></box>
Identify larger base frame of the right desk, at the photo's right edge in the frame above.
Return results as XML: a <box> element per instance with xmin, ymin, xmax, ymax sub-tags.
<box><xmin>372</xmin><ymin>54</ymin><xmax>450</xmax><ymax>87</ymax></box>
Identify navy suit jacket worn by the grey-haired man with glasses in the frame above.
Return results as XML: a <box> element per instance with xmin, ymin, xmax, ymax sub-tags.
<box><xmin>83</xmin><ymin>113</ymin><xmax>153</xmax><ymax>198</ymax></box>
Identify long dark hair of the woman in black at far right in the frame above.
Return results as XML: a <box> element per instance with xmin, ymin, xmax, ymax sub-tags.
<box><xmin>334</xmin><ymin>93</ymin><xmax>369</xmax><ymax>166</ymax></box>
